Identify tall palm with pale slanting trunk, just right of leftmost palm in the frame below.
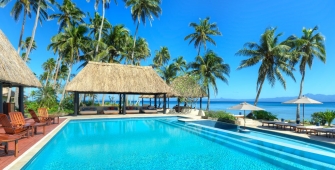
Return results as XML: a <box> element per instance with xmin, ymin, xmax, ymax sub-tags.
<box><xmin>24</xmin><ymin>0</ymin><xmax>49</xmax><ymax>62</ymax></box>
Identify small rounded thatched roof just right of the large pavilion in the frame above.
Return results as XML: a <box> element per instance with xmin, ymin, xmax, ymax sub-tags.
<box><xmin>170</xmin><ymin>75</ymin><xmax>208</xmax><ymax>98</ymax></box>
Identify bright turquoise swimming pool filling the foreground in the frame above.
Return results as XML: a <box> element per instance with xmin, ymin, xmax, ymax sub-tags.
<box><xmin>23</xmin><ymin>117</ymin><xmax>335</xmax><ymax>169</ymax></box>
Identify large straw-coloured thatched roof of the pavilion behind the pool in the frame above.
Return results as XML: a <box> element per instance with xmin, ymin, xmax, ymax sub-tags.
<box><xmin>65</xmin><ymin>62</ymin><xmax>171</xmax><ymax>94</ymax></box>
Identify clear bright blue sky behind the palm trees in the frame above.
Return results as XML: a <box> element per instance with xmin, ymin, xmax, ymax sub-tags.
<box><xmin>0</xmin><ymin>0</ymin><xmax>335</xmax><ymax>99</ymax></box>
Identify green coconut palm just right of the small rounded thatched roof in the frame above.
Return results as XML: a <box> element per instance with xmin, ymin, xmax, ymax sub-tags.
<box><xmin>189</xmin><ymin>50</ymin><xmax>230</xmax><ymax>110</ymax></box>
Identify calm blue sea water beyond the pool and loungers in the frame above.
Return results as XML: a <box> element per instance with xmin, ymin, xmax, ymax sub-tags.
<box><xmin>138</xmin><ymin>100</ymin><xmax>335</xmax><ymax>120</ymax></box>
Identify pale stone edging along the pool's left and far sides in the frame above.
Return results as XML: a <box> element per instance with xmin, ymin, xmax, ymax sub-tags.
<box><xmin>4</xmin><ymin>114</ymin><xmax>181</xmax><ymax>170</ymax></box>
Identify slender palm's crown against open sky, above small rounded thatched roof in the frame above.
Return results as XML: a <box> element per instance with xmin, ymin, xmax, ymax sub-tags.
<box><xmin>184</xmin><ymin>17</ymin><xmax>221</xmax><ymax>55</ymax></box>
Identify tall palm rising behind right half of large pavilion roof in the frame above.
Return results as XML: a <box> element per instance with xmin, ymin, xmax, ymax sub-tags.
<box><xmin>125</xmin><ymin>0</ymin><xmax>162</xmax><ymax>63</ymax></box>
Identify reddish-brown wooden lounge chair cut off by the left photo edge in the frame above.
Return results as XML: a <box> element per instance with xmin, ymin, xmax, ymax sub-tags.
<box><xmin>0</xmin><ymin>113</ymin><xmax>30</xmax><ymax>138</ymax></box>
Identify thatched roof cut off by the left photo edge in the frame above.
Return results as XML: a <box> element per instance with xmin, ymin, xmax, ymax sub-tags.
<box><xmin>0</xmin><ymin>30</ymin><xmax>42</xmax><ymax>87</ymax></box>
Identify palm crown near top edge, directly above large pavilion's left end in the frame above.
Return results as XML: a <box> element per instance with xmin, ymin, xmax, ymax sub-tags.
<box><xmin>49</xmin><ymin>0</ymin><xmax>85</xmax><ymax>32</ymax></box>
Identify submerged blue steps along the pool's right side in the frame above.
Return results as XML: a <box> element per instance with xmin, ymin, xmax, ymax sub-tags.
<box><xmin>160</xmin><ymin>120</ymin><xmax>335</xmax><ymax>169</ymax></box>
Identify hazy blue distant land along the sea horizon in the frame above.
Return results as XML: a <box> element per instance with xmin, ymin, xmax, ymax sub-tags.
<box><xmin>211</xmin><ymin>93</ymin><xmax>335</xmax><ymax>102</ymax></box>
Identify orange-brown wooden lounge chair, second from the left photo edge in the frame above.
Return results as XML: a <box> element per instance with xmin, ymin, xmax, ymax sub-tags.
<box><xmin>9</xmin><ymin>112</ymin><xmax>47</xmax><ymax>136</ymax></box>
